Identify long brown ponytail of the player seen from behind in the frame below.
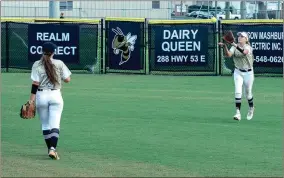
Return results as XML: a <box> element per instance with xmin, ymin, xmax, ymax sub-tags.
<box><xmin>42</xmin><ymin>54</ymin><xmax>58</xmax><ymax>85</ymax></box>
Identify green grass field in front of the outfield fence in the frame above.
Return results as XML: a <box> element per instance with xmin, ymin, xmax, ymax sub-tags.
<box><xmin>1</xmin><ymin>73</ymin><xmax>283</xmax><ymax>177</ymax></box>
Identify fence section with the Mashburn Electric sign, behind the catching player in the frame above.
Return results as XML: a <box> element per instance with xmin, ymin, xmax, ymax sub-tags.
<box><xmin>219</xmin><ymin>21</ymin><xmax>283</xmax><ymax>76</ymax></box>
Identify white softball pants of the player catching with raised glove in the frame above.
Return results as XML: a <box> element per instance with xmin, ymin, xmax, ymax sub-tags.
<box><xmin>234</xmin><ymin>69</ymin><xmax>254</xmax><ymax>100</ymax></box>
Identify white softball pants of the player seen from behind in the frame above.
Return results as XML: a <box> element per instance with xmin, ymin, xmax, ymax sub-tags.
<box><xmin>36</xmin><ymin>90</ymin><xmax>63</xmax><ymax>130</ymax></box>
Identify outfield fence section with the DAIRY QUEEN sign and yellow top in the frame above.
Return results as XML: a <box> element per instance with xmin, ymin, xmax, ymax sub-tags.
<box><xmin>148</xmin><ymin>20</ymin><xmax>217</xmax><ymax>75</ymax></box>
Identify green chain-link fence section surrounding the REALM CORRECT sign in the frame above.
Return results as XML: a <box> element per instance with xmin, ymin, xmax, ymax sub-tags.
<box><xmin>1</xmin><ymin>20</ymin><xmax>102</xmax><ymax>73</ymax></box>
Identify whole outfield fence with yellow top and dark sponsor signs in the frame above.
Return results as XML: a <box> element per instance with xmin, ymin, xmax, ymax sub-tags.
<box><xmin>1</xmin><ymin>17</ymin><xmax>283</xmax><ymax>76</ymax></box>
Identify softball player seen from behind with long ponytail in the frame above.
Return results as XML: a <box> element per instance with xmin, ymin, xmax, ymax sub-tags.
<box><xmin>30</xmin><ymin>42</ymin><xmax>71</xmax><ymax>160</ymax></box>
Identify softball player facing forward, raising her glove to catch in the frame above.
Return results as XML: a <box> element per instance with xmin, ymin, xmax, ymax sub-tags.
<box><xmin>219</xmin><ymin>32</ymin><xmax>254</xmax><ymax>120</ymax></box>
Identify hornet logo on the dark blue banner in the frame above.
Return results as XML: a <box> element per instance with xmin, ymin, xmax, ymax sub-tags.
<box><xmin>112</xmin><ymin>27</ymin><xmax>137</xmax><ymax>65</ymax></box>
